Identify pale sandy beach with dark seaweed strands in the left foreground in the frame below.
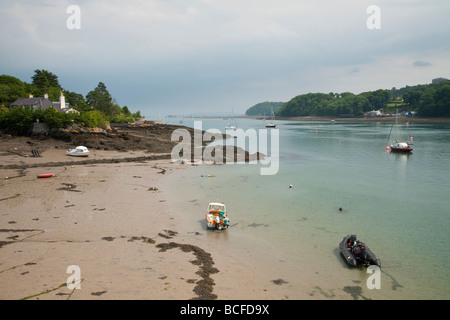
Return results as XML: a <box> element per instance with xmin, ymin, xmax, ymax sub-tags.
<box><xmin>0</xmin><ymin>129</ymin><xmax>316</xmax><ymax>300</ymax></box>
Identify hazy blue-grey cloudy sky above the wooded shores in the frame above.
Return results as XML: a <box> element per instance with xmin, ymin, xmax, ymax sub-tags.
<box><xmin>0</xmin><ymin>0</ymin><xmax>450</xmax><ymax>118</ymax></box>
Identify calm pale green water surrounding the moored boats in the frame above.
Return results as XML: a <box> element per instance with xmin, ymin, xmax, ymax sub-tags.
<box><xmin>162</xmin><ymin>119</ymin><xmax>450</xmax><ymax>299</ymax></box>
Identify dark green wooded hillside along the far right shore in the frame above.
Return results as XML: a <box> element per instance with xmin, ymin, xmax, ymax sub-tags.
<box><xmin>246</xmin><ymin>80</ymin><xmax>450</xmax><ymax>117</ymax></box>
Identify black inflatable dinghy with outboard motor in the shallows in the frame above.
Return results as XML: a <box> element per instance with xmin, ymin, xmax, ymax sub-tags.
<box><xmin>339</xmin><ymin>235</ymin><xmax>381</xmax><ymax>267</ymax></box>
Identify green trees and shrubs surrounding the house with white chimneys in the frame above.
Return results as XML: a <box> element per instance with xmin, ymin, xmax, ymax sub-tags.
<box><xmin>0</xmin><ymin>70</ymin><xmax>142</xmax><ymax>133</ymax></box>
